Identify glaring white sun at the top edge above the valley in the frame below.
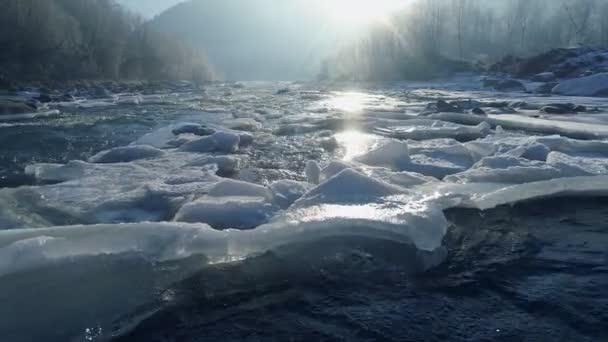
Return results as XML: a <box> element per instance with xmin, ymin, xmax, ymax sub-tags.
<box><xmin>321</xmin><ymin>0</ymin><xmax>408</xmax><ymax>28</ymax></box>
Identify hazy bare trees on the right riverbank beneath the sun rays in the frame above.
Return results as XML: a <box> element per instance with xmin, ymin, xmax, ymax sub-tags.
<box><xmin>321</xmin><ymin>0</ymin><xmax>608</xmax><ymax>80</ymax></box>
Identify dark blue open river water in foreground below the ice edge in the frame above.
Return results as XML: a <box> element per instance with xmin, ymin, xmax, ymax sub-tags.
<box><xmin>110</xmin><ymin>198</ymin><xmax>608</xmax><ymax>341</ymax></box>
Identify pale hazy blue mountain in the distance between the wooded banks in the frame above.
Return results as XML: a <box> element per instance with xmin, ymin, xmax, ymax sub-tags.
<box><xmin>151</xmin><ymin>0</ymin><xmax>337</xmax><ymax>80</ymax></box>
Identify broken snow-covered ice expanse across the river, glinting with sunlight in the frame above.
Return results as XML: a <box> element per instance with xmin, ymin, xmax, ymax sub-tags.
<box><xmin>0</xmin><ymin>81</ymin><xmax>608</xmax><ymax>284</ymax></box>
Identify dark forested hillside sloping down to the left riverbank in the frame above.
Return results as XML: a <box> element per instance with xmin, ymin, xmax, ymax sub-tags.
<box><xmin>0</xmin><ymin>0</ymin><xmax>212</xmax><ymax>81</ymax></box>
